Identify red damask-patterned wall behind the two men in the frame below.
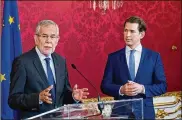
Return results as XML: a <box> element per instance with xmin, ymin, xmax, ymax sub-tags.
<box><xmin>3</xmin><ymin>1</ymin><xmax>181</xmax><ymax>97</ymax></box>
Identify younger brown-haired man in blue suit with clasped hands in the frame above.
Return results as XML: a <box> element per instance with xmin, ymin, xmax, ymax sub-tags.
<box><xmin>101</xmin><ymin>16</ymin><xmax>167</xmax><ymax>119</ymax></box>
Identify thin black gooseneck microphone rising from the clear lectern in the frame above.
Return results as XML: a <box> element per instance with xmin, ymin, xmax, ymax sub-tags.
<box><xmin>71</xmin><ymin>64</ymin><xmax>104</xmax><ymax>114</ymax></box>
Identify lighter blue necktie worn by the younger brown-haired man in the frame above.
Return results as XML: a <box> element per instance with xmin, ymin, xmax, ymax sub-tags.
<box><xmin>129</xmin><ymin>50</ymin><xmax>135</xmax><ymax>81</ymax></box>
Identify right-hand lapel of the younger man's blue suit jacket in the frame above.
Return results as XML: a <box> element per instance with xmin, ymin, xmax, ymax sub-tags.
<box><xmin>135</xmin><ymin>47</ymin><xmax>147</xmax><ymax>81</ymax></box>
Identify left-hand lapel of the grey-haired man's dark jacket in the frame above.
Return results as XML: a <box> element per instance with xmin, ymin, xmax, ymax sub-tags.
<box><xmin>33</xmin><ymin>49</ymin><xmax>49</xmax><ymax>86</ymax></box>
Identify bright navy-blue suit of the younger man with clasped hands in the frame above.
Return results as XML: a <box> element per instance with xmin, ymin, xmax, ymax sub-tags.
<box><xmin>101</xmin><ymin>47</ymin><xmax>167</xmax><ymax>119</ymax></box>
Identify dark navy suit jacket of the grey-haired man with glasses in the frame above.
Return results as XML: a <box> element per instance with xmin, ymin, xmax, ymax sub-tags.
<box><xmin>8</xmin><ymin>48</ymin><xmax>74</xmax><ymax>118</ymax></box>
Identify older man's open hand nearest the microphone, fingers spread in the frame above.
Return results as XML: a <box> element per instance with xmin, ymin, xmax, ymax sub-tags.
<box><xmin>73</xmin><ymin>84</ymin><xmax>89</xmax><ymax>102</ymax></box>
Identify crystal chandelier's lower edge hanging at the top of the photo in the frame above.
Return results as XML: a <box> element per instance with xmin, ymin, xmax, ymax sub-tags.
<box><xmin>90</xmin><ymin>0</ymin><xmax>123</xmax><ymax>11</ymax></box>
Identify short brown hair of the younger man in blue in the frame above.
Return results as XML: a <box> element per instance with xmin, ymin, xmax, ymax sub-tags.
<box><xmin>124</xmin><ymin>16</ymin><xmax>147</xmax><ymax>32</ymax></box>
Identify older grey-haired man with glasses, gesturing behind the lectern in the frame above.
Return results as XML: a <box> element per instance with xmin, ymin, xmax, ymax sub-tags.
<box><xmin>8</xmin><ymin>20</ymin><xmax>89</xmax><ymax>119</ymax></box>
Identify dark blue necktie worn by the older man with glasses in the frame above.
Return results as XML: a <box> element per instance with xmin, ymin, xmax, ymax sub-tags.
<box><xmin>45</xmin><ymin>58</ymin><xmax>56</xmax><ymax>101</ymax></box>
